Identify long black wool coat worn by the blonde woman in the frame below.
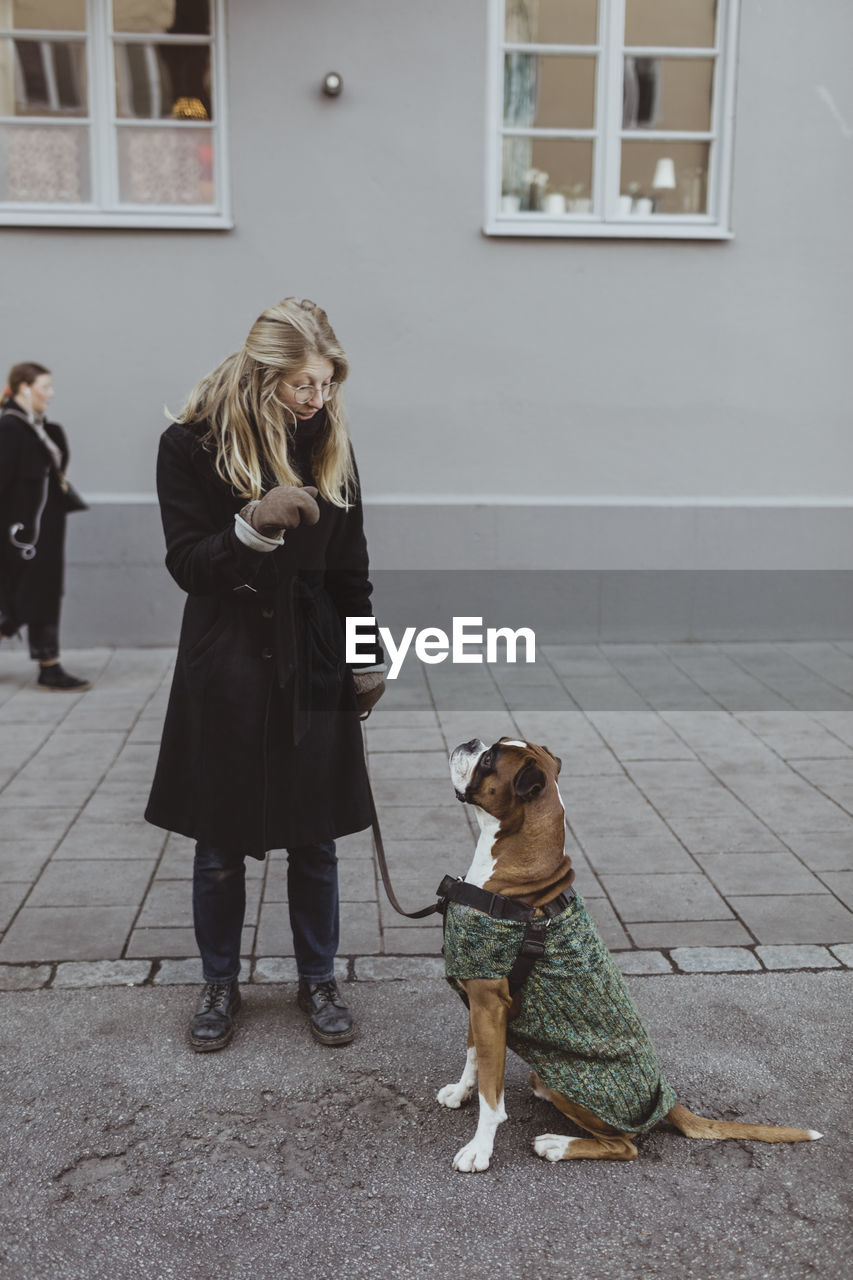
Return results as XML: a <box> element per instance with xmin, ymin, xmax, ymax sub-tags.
<box><xmin>145</xmin><ymin>413</ymin><xmax>382</xmax><ymax>858</ymax></box>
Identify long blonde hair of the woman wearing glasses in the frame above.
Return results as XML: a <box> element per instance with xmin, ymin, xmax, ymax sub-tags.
<box><xmin>174</xmin><ymin>298</ymin><xmax>356</xmax><ymax>508</ymax></box>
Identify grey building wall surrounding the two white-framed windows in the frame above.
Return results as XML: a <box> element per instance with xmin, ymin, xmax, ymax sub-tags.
<box><xmin>0</xmin><ymin>0</ymin><xmax>853</xmax><ymax>643</ymax></box>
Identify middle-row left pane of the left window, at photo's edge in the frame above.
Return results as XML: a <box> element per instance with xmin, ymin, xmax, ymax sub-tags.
<box><xmin>0</xmin><ymin>40</ymin><xmax>87</xmax><ymax>115</ymax></box>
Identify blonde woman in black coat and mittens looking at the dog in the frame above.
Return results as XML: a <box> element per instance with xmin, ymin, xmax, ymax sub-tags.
<box><xmin>146</xmin><ymin>298</ymin><xmax>384</xmax><ymax>1052</ymax></box>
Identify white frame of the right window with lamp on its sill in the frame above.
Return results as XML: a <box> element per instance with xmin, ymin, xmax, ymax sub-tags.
<box><xmin>483</xmin><ymin>0</ymin><xmax>739</xmax><ymax>239</ymax></box>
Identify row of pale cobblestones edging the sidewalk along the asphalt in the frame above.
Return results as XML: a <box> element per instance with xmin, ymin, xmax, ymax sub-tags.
<box><xmin>0</xmin><ymin>942</ymin><xmax>853</xmax><ymax>992</ymax></box>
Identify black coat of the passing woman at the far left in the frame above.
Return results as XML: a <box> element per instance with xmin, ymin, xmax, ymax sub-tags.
<box><xmin>0</xmin><ymin>401</ymin><xmax>68</xmax><ymax>634</ymax></box>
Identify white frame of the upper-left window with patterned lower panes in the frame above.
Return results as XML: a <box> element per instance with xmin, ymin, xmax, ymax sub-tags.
<box><xmin>0</xmin><ymin>0</ymin><xmax>233</xmax><ymax>230</ymax></box>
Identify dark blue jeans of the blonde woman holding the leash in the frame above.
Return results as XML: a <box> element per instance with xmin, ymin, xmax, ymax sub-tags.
<box><xmin>192</xmin><ymin>841</ymin><xmax>339</xmax><ymax>982</ymax></box>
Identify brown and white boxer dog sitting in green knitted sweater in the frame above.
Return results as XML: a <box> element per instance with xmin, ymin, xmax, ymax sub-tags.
<box><xmin>437</xmin><ymin>737</ymin><xmax>822</xmax><ymax>1172</ymax></box>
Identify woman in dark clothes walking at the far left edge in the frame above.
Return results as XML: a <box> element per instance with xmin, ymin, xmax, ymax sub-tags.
<box><xmin>0</xmin><ymin>361</ymin><xmax>90</xmax><ymax>692</ymax></box>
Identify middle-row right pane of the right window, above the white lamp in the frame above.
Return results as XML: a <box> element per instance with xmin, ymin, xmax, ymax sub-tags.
<box><xmin>622</xmin><ymin>56</ymin><xmax>715</xmax><ymax>131</ymax></box>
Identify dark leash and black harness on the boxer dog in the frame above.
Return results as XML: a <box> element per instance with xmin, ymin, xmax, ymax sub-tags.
<box><xmin>368</xmin><ymin>782</ymin><xmax>576</xmax><ymax>1004</ymax></box>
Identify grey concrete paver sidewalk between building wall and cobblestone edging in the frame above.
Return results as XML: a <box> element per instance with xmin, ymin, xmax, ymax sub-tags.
<box><xmin>0</xmin><ymin>643</ymin><xmax>853</xmax><ymax>987</ymax></box>
